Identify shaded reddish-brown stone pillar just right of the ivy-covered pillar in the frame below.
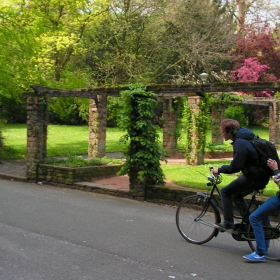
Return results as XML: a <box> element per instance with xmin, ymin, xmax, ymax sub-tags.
<box><xmin>162</xmin><ymin>98</ymin><xmax>178</xmax><ymax>156</ymax></box>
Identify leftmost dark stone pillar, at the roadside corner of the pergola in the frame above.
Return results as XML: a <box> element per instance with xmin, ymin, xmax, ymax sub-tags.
<box><xmin>26</xmin><ymin>96</ymin><xmax>47</xmax><ymax>182</ymax></box>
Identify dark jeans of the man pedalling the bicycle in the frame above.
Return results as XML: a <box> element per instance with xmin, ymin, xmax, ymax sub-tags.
<box><xmin>221</xmin><ymin>174</ymin><xmax>259</xmax><ymax>226</ymax></box>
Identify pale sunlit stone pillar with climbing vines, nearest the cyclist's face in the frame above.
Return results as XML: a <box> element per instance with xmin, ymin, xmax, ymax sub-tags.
<box><xmin>187</xmin><ymin>96</ymin><xmax>204</xmax><ymax>165</ymax></box>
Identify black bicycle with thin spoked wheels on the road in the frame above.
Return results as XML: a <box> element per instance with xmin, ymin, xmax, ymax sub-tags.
<box><xmin>176</xmin><ymin>167</ymin><xmax>280</xmax><ymax>260</ymax></box>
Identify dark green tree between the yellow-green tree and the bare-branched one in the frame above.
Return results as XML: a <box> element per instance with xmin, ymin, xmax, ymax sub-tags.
<box><xmin>85</xmin><ymin>0</ymin><xmax>164</xmax><ymax>85</ymax></box>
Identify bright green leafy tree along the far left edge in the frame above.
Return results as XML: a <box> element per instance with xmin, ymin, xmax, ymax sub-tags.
<box><xmin>0</xmin><ymin>1</ymin><xmax>40</xmax><ymax>122</ymax></box>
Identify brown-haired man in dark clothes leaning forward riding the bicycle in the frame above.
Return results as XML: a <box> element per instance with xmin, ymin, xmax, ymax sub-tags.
<box><xmin>213</xmin><ymin>119</ymin><xmax>269</xmax><ymax>231</ymax></box>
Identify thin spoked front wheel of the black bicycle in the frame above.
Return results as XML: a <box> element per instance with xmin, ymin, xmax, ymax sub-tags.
<box><xmin>176</xmin><ymin>194</ymin><xmax>220</xmax><ymax>244</ymax></box>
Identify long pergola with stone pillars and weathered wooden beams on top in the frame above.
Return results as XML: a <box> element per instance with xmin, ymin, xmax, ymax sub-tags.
<box><xmin>24</xmin><ymin>82</ymin><xmax>280</xmax><ymax>181</ymax></box>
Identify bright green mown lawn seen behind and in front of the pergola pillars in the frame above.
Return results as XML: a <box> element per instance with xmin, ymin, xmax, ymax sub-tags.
<box><xmin>2</xmin><ymin>124</ymin><xmax>277</xmax><ymax>195</ymax></box>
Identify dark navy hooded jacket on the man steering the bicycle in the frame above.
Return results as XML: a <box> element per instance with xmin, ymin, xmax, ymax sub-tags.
<box><xmin>218</xmin><ymin>127</ymin><xmax>269</xmax><ymax>187</ymax></box>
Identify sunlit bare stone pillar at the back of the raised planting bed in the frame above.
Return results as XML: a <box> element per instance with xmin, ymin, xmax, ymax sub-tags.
<box><xmin>88</xmin><ymin>95</ymin><xmax>107</xmax><ymax>157</ymax></box>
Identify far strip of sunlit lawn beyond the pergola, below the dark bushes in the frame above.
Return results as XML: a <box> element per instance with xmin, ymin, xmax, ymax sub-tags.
<box><xmin>1</xmin><ymin>124</ymin><xmax>268</xmax><ymax>159</ymax></box>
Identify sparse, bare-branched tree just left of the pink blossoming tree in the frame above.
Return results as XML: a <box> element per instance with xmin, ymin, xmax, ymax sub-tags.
<box><xmin>151</xmin><ymin>0</ymin><xmax>235</xmax><ymax>82</ymax></box>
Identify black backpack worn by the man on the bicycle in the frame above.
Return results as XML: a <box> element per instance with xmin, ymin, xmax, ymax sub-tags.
<box><xmin>249</xmin><ymin>136</ymin><xmax>280</xmax><ymax>176</ymax></box>
